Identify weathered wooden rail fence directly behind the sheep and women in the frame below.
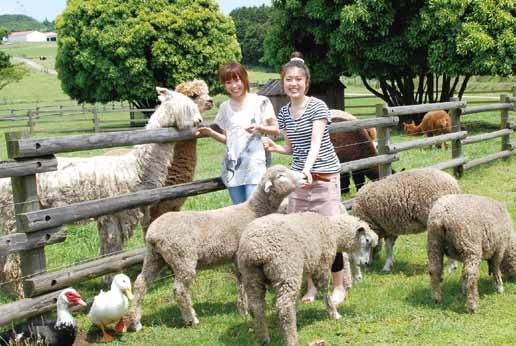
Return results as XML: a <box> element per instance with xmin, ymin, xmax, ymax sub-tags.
<box><xmin>0</xmin><ymin>93</ymin><xmax>516</xmax><ymax>325</ymax></box>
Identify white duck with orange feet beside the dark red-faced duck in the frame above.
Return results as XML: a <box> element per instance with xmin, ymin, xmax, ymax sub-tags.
<box><xmin>88</xmin><ymin>274</ymin><xmax>133</xmax><ymax>342</ymax></box>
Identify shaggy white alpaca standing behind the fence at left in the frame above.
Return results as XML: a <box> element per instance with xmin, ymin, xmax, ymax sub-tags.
<box><xmin>0</xmin><ymin>88</ymin><xmax>206</xmax><ymax>295</ymax></box>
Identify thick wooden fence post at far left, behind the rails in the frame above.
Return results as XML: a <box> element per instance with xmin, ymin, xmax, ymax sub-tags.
<box><xmin>5</xmin><ymin>132</ymin><xmax>46</xmax><ymax>293</ymax></box>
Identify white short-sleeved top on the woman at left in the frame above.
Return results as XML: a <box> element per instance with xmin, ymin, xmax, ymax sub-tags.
<box><xmin>215</xmin><ymin>93</ymin><xmax>274</xmax><ymax>187</ymax></box>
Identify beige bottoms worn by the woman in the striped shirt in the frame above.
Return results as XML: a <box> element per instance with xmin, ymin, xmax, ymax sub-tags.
<box><xmin>287</xmin><ymin>174</ymin><xmax>341</xmax><ymax>216</ymax></box>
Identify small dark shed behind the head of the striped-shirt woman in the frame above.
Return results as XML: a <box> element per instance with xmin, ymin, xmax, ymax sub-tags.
<box><xmin>258</xmin><ymin>79</ymin><xmax>346</xmax><ymax>112</ymax></box>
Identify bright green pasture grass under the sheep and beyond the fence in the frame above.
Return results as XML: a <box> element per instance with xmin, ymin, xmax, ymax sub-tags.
<box><xmin>0</xmin><ymin>43</ymin><xmax>516</xmax><ymax>346</ymax></box>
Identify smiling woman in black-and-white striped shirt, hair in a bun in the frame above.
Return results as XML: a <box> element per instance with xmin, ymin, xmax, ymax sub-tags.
<box><xmin>262</xmin><ymin>53</ymin><xmax>346</xmax><ymax>304</ymax></box>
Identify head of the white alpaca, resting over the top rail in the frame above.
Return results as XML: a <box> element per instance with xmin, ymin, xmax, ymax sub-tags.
<box><xmin>146</xmin><ymin>87</ymin><xmax>202</xmax><ymax>130</ymax></box>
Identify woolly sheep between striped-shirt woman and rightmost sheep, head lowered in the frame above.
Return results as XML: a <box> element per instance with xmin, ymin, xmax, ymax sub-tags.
<box><xmin>351</xmin><ymin>168</ymin><xmax>461</xmax><ymax>272</ymax></box>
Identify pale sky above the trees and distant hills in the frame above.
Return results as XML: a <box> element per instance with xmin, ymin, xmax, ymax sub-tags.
<box><xmin>0</xmin><ymin>0</ymin><xmax>271</xmax><ymax>22</ymax></box>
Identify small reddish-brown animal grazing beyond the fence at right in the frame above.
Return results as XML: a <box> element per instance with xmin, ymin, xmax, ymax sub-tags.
<box><xmin>403</xmin><ymin>110</ymin><xmax>451</xmax><ymax>149</ymax></box>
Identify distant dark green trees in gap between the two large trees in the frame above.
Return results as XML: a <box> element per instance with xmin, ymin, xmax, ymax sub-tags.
<box><xmin>229</xmin><ymin>5</ymin><xmax>272</xmax><ymax>66</ymax></box>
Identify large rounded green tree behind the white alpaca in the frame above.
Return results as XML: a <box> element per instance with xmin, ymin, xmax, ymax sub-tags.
<box><xmin>56</xmin><ymin>0</ymin><xmax>240</xmax><ymax>108</ymax></box>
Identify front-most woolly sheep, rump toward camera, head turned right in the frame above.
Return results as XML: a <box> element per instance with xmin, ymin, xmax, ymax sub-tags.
<box><xmin>237</xmin><ymin>212</ymin><xmax>378</xmax><ymax>345</ymax></box>
